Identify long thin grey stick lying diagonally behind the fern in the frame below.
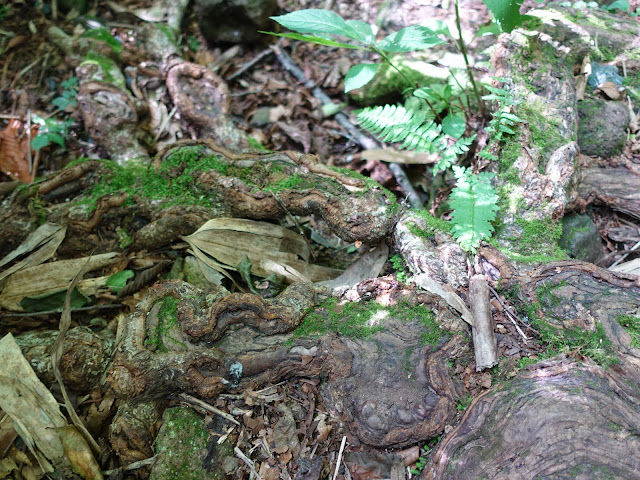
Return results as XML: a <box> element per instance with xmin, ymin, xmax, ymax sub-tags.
<box><xmin>271</xmin><ymin>45</ymin><xmax>423</xmax><ymax>208</ymax></box>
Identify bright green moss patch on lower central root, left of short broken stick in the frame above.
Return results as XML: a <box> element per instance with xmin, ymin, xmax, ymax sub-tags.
<box><xmin>293</xmin><ymin>297</ymin><xmax>448</xmax><ymax>346</ymax></box>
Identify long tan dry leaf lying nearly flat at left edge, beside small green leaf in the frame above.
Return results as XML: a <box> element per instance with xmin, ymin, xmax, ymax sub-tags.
<box><xmin>0</xmin><ymin>252</ymin><xmax>120</xmax><ymax>312</ymax></box>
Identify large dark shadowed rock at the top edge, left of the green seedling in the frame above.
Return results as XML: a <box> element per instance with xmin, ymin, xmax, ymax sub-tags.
<box><xmin>196</xmin><ymin>0</ymin><xmax>278</xmax><ymax>44</ymax></box>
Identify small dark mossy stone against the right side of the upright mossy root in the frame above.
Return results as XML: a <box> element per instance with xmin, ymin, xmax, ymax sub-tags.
<box><xmin>559</xmin><ymin>215</ymin><xmax>602</xmax><ymax>263</ymax></box>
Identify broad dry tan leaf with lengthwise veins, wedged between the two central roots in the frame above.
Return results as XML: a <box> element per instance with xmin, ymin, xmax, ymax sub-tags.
<box><xmin>182</xmin><ymin>218</ymin><xmax>340</xmax><ymax>282</ymax></box>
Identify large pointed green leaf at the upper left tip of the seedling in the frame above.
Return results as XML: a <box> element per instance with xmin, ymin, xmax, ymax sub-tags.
<box><xmin>271</xmin><ymin>8</ymin><xmax>362</xmax><ymax>40</ymax></box>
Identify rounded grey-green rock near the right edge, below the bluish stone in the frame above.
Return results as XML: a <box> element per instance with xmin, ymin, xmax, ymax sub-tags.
<box><xmin>578</xmin><ymin>98</ymin><xmax>629</xmax><ymax>158</ymax></box>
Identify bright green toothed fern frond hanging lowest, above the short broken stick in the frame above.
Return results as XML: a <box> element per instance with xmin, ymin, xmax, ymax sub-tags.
<box><xmin>450</xmin><ymin>166</ymin><xmax>498</xmax><ymax>252</ymax></box>
